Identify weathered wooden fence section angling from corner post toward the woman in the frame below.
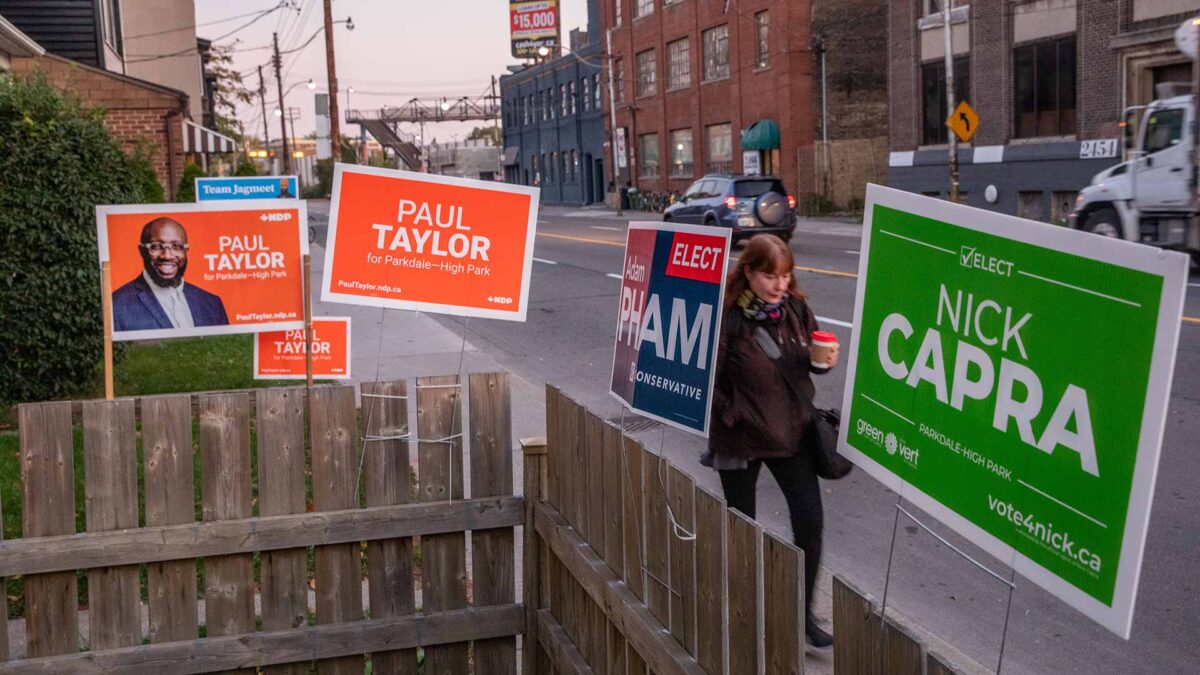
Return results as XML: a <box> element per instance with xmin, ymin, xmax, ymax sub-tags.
<box><xmin>523</xmin><ymin>387</ymin><xmax>804</xmax><ymax>675</ymax></box>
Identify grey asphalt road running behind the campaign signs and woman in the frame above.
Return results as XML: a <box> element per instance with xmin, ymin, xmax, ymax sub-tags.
<box><xmin>311</xmin><ymin>203</ymin><xmax>1200</xmax><ymax>674</ymax></box>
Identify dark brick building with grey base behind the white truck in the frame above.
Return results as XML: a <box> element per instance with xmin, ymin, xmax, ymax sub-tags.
<box><xmin>888</xmin><ymin>0</ymin><xmax>1200</xmax><ymax>222</ymax></box>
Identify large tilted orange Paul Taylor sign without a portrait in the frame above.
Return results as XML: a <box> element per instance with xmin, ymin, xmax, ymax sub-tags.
<box><xmin>320</xmin><ymin>165</ymin><xmax>538</xmax><ymax>321</ymax></box>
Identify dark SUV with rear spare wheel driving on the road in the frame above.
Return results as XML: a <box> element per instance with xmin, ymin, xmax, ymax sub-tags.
<box><xmin>662</xmin><ymin>174</ymin><xmax>796</xmax><ymax>241</ymax></box>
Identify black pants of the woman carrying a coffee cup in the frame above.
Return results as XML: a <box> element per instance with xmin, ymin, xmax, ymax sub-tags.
<box><xmin>718</xmin><ymin>452</ymin><xmax>824</xmax><ymax>616</ymax></box>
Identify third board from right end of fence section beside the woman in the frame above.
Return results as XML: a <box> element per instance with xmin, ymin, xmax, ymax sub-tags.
<box><xmin>696</xmin><ymin>489</ymin><xmax>728</xmax><ymax>675</ymax></box>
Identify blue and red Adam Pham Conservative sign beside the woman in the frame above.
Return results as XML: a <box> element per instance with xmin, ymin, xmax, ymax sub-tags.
<box><xmin>610</xmin><ymin>222</ymin><xmax>730</xmax><ymax>436</ymax></box>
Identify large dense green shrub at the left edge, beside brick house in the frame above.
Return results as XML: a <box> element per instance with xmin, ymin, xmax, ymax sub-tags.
<box><xmin>0</xmin><ymin>73</ymin><xmax>149</xmax><ymax>402</ymax></box>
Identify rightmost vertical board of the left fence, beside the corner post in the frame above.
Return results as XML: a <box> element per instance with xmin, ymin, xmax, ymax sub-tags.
<box><xmin>468</xmin><ymin>372</ymin><xmax>517</xmax><ymax>675</ymax></box>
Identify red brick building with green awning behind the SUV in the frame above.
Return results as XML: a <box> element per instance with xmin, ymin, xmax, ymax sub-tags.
<box><xmin>602</xmin><ymin>0</ymin><xmax>816</xmax><ymax>193</ymax></box>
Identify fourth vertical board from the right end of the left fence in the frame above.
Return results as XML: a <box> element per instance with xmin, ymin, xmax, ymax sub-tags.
<box><xmin>308</xmin><ymin>387</ymin><xmax>362</xmax><ymax>675</ymax></box>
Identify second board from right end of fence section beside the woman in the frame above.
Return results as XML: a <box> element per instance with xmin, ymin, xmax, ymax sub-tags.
<box><xmin>726</xmin><ymin>509</ymin><xmax>762</xmax><ymax>673</ymax></box>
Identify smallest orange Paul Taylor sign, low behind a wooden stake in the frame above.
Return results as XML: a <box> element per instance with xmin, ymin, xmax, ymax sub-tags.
<box><xmin>254</xmin><ymin>316</ymin><xmax>350</xmax><ymax>380</ymax></box>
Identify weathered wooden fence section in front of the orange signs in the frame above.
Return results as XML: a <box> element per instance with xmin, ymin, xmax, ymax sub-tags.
<box><xmin>0</xmin><ymin>374</ymin><xmax>524</xmax><ymax>675</ymax></box>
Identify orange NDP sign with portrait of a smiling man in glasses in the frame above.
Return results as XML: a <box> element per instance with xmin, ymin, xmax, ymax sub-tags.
<box><xmin>96</xmin><ymin>199</ymin><xmax>308</xmax><ymax>340</ymax></box>
